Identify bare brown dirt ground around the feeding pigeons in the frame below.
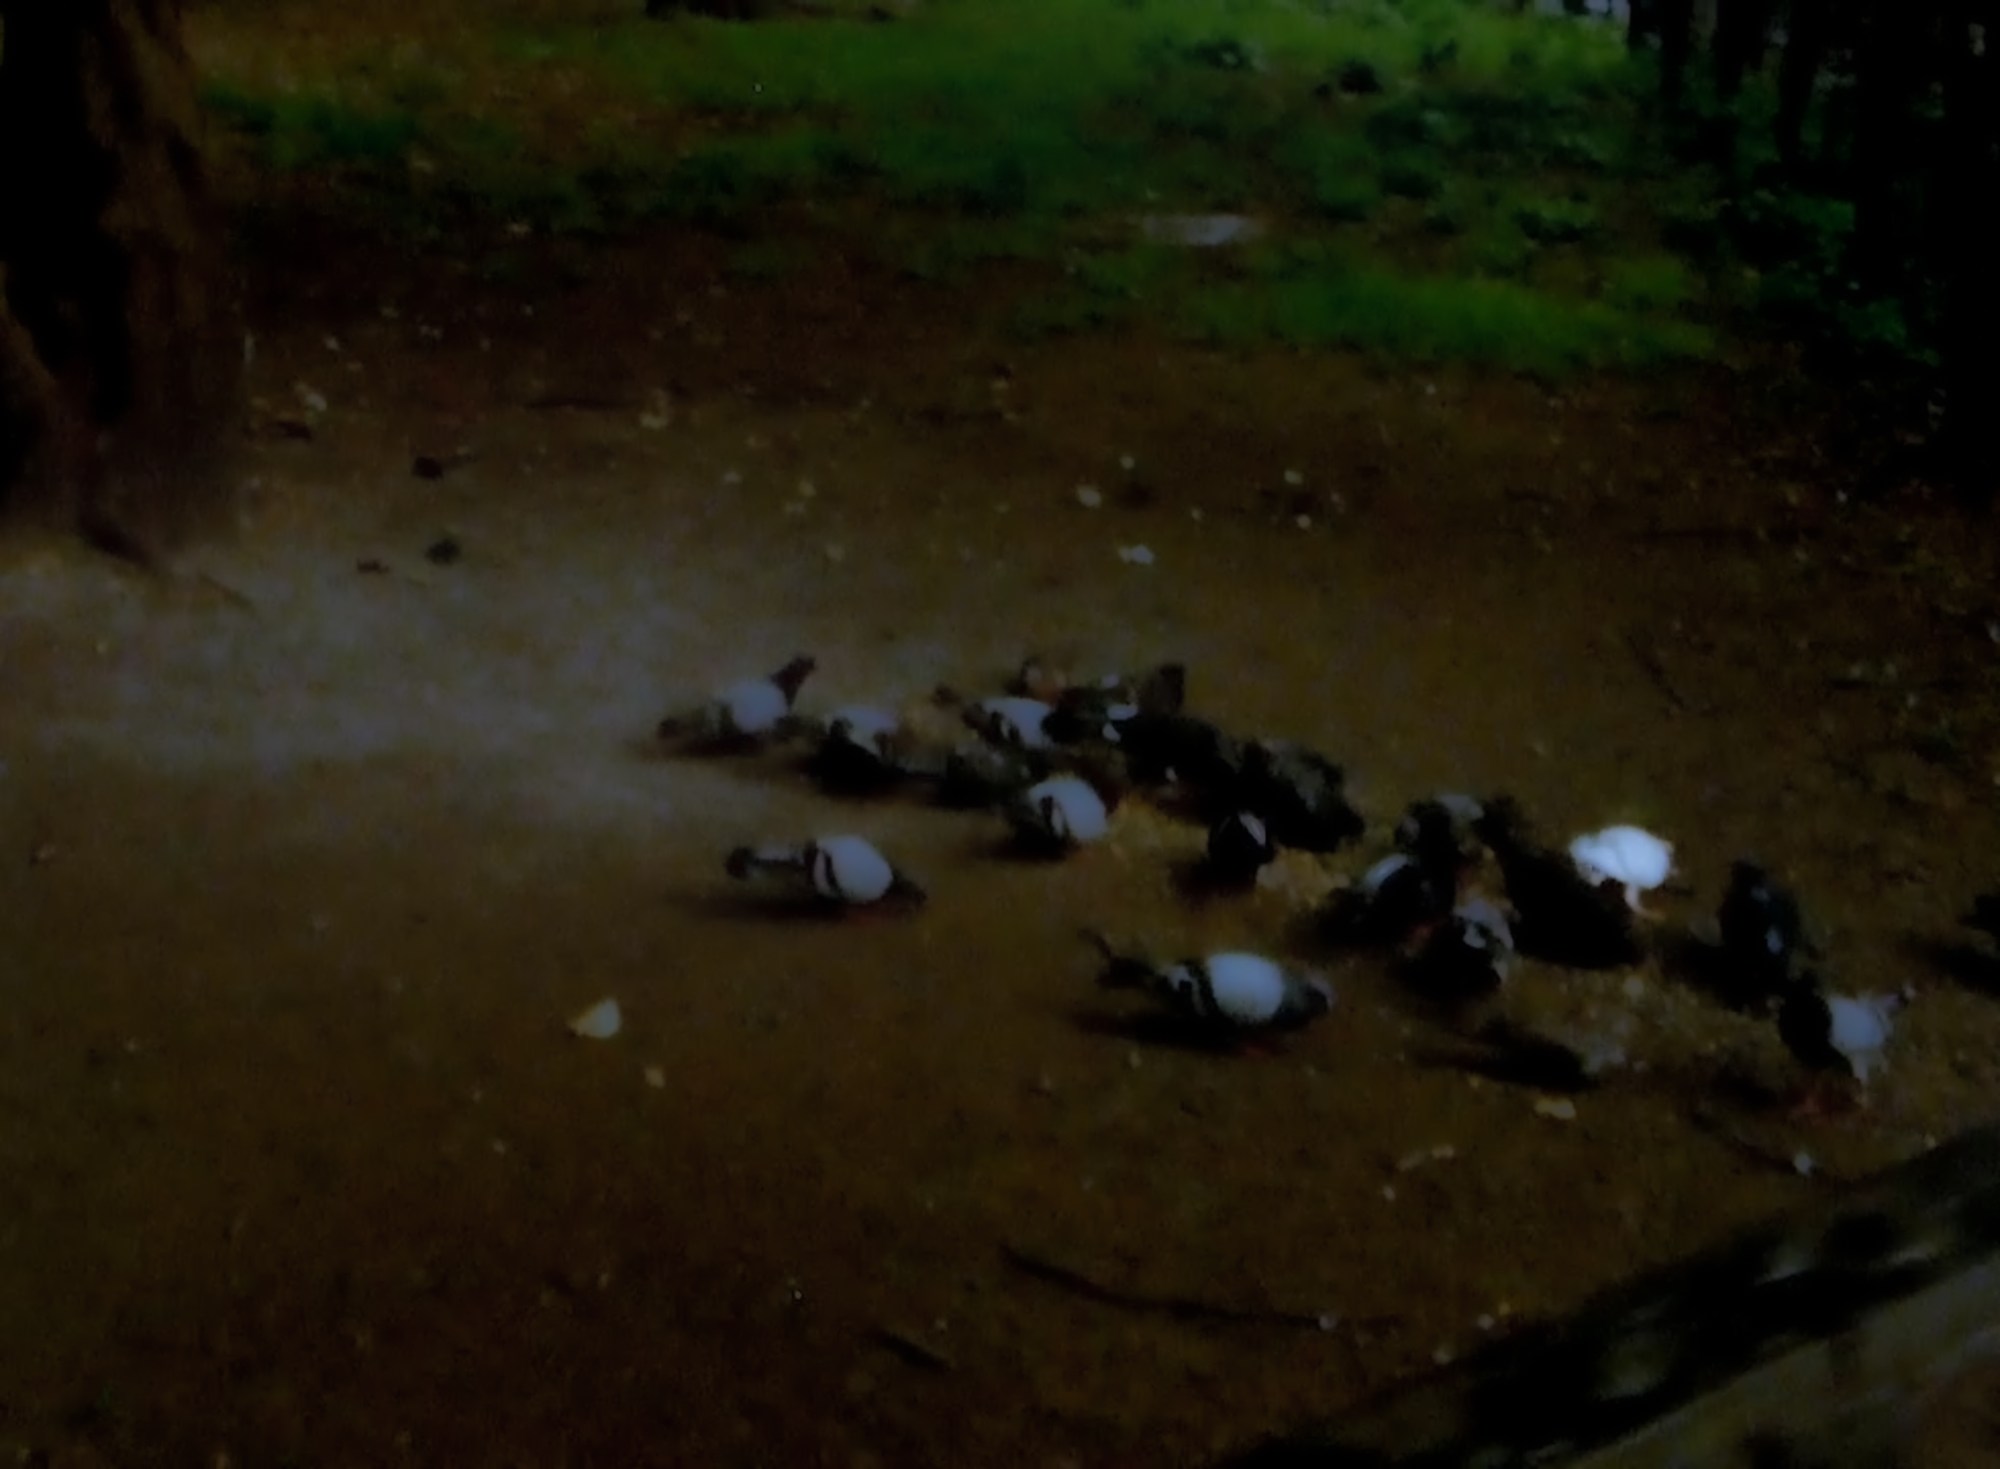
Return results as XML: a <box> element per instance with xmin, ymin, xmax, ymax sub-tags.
<box><xmin>0</xmin><ymin>221</ymin><xmax>2000</xmax><ymax>1469</ymax></box>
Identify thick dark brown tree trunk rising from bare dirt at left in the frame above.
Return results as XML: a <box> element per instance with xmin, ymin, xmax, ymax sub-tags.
<box><xmin>0</xmin><ymin>0</ymin><xmax>242</xmax><ymax>546</ymax></box>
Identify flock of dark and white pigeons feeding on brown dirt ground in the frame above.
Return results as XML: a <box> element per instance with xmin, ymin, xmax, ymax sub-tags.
<box><xmin>660</xmin><ymin>656</ymin><xmax>2000</xmax><ymax>1109</ymax></box>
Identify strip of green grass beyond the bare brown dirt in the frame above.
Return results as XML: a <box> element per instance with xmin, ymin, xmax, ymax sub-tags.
<box><xmin>196</xmin><ymin>0</ymin><xmax>1736</xmax><ymax>372</ymax></box>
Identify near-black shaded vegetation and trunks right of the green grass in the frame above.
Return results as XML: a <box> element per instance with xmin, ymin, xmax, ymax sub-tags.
<box><xmin>1628</xmin><ymin>0</ymin><xmax>2000</xmax><ymax>504</ymax></box>
